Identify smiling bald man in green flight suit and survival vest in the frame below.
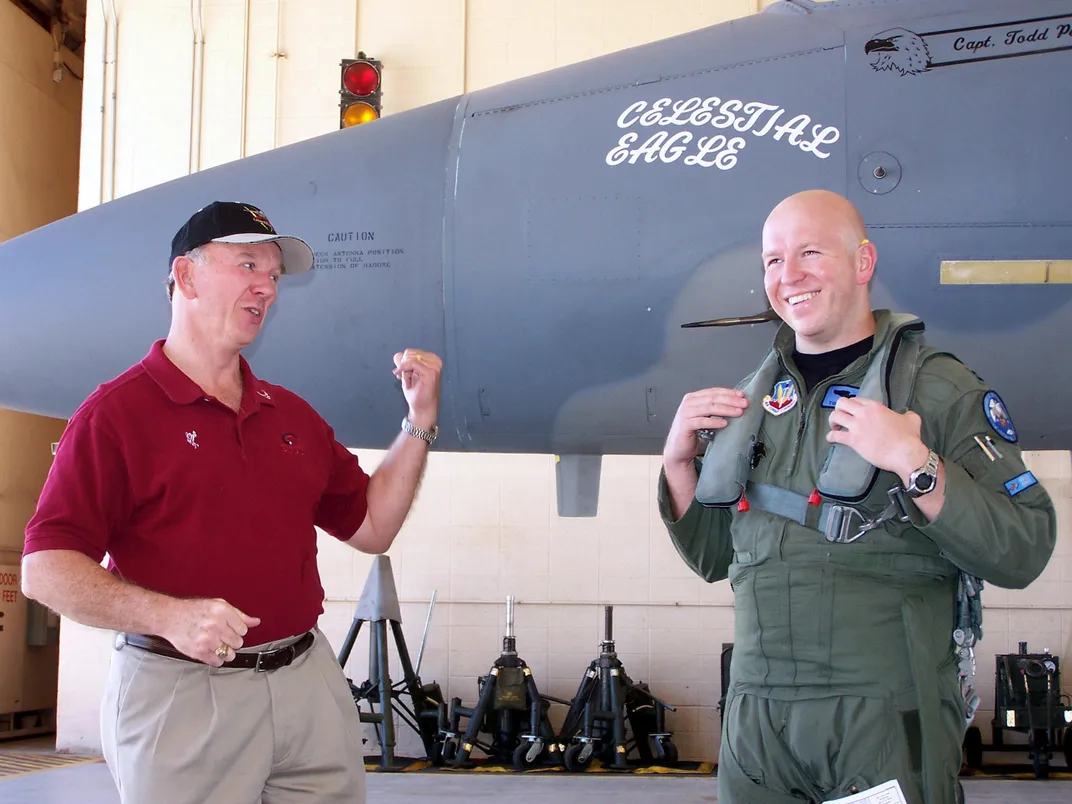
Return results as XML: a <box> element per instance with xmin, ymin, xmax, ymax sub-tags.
<box><xmin>658</xmin><ymin>190</ymin><xmax>1056</xmax><ymax>804</ymax></box>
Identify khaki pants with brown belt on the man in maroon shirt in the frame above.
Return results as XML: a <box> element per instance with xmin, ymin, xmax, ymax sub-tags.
<box><xmin>101</xmin><ymin>630</ymin><xmax>366</xmax><ymax>804</ymax></box>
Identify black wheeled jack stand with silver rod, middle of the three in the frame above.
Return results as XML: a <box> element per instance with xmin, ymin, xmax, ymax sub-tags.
<box><xmin>441</xmin><ymin>596</ymin><xmax>569</xmax><ymax>771</ymax></box>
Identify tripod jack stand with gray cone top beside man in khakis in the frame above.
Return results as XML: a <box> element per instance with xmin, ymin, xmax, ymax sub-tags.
<box><xmin>339</xmin><ymin>555</ymin><xmax>444</xmax><ymax>771</ymax></box>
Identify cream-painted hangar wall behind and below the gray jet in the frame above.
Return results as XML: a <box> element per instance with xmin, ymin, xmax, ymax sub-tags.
<box><xmin>57</xmin><ymin>0</ymin><xmax>1072</xmax><ymax>759</ymax></box>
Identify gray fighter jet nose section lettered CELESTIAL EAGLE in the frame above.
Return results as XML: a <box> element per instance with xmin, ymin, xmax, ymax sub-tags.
<box><xmin>0</xmin><ymin>0</ymin><xmax>1072</xmax><ymax>463</ymax></box>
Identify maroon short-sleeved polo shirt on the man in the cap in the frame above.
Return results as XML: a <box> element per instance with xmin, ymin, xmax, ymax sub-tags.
<box><xmin>25</xmin><ymin>341</ymin><xmax>369</xmax><ymax>644</ymax></box>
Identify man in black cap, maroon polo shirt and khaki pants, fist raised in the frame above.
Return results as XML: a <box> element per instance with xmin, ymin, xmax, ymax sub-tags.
<box><xmin>23</xmin><ymin>202</ymin><xmax>442</xmax><ymax>804</ymax></box>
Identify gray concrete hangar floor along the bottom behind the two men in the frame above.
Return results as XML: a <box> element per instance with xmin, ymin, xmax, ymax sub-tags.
<box><xmin>0</xmin><ymin>744</ymin><xmax>1072</xmax><ymax>804</ymax></box>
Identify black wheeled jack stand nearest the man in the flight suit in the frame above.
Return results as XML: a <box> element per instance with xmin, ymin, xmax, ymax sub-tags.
<box><xmin>559</xmin><ymin>606</ymin><xmax>678</xmax><ymax>771</ymax></box>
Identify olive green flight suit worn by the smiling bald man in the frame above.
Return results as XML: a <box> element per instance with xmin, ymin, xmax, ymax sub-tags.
<box><xmin>658</xmin><ymin>311</ymin><xmax>1057</xmax><ymax>804</ymax></box>
